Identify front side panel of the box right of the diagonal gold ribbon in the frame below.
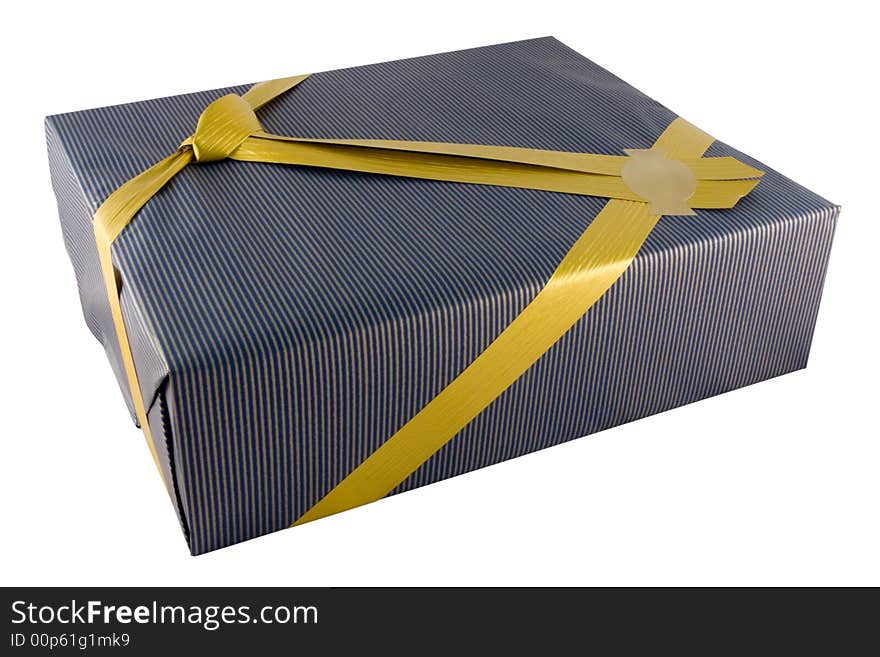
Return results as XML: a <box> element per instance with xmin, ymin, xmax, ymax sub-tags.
<box><xmin>395</xmin><ymin>207</ymin><xmax>838</xmax><ymax>492</ymax></box>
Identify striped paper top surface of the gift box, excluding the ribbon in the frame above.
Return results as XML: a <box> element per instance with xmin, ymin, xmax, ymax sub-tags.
<box><xmin>47</xmin><ymin>38</ymin><xmax>833</xmax><ymax>369</ymax></box>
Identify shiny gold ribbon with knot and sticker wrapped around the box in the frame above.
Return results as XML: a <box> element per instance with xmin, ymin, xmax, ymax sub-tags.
<box><xmin>94</xmin><ymin>76</ymin><xmax>762</xmax><ymax>512</ymax></box>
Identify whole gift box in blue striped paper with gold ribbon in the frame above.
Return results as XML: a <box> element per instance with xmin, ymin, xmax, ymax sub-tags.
<box><xmin>46</xmin><ymin>38</ymin><xmax>838</xmax><ymax>554</ymax></box>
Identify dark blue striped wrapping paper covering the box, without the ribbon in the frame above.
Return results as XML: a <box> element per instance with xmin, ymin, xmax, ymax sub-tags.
<box><xmin>46</xmin><ymin>38</ymin><xmax>838</xmax><ymax>554</ymax></box>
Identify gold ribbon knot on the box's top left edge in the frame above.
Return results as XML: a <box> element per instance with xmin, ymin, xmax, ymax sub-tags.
<box><xmin>190</xmin><ymin>94</ymin><xmax>262</xmax><ymax>162</ymax></box>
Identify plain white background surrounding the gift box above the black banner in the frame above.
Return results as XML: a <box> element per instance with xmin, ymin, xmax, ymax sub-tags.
<box><xmin>0</xmin><ymin>0</ymin><xmax>880</xmax><ymax>586</ymax></box>
